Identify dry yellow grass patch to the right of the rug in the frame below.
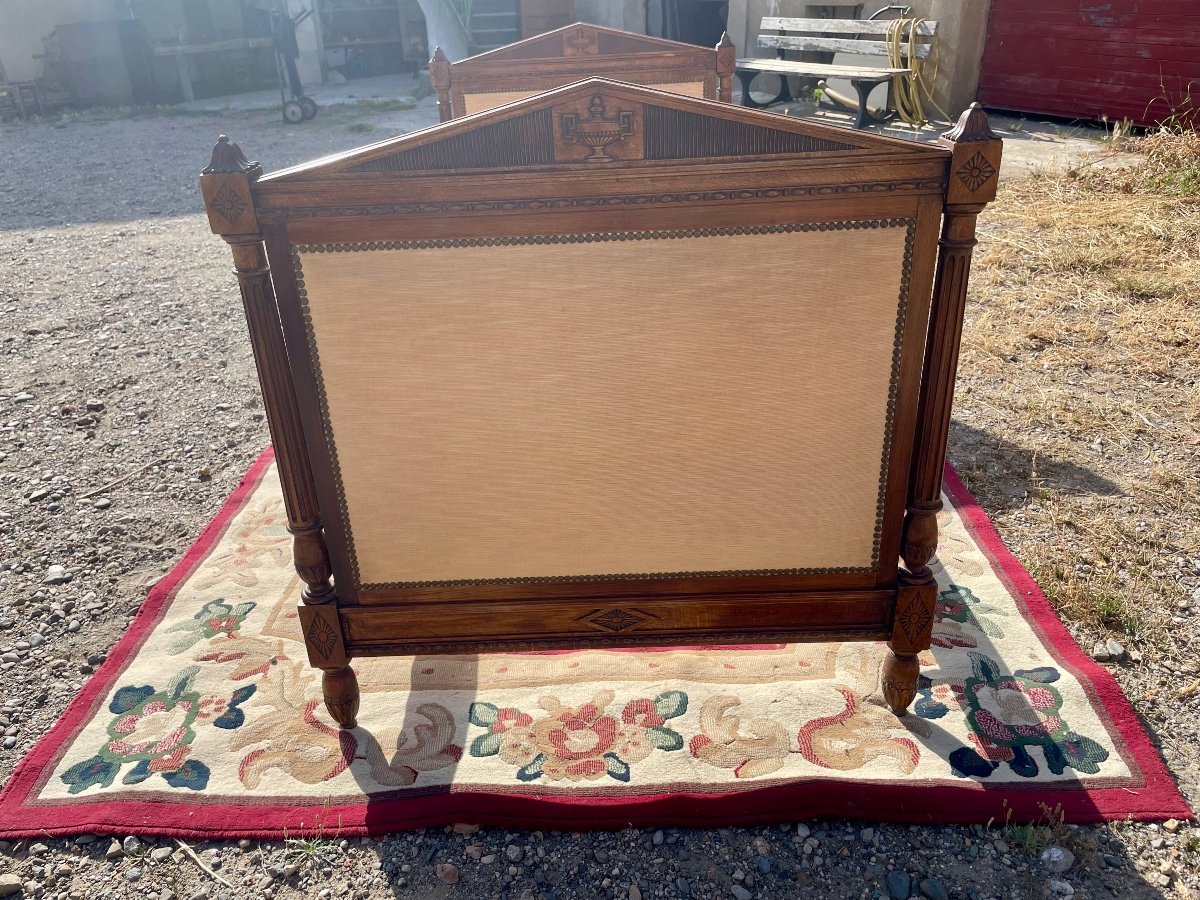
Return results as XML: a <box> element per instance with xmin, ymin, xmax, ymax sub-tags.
<box><xmin>952</xmin><ymin>134</ymin><xmax>1200</xmax><ymax>661</ymax></box>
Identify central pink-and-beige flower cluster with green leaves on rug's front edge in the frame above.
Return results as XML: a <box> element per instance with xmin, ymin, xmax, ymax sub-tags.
<box><xmin>468</xmin><ymin>690</ymin><xmax>688</xmax><ymax>782</ymax></box>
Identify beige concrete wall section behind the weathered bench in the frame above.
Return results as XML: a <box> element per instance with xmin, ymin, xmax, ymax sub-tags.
<box><xmin>728</xmin><ymin>0</ymin><xmax>992</xmax><ymax>116</ymax></box>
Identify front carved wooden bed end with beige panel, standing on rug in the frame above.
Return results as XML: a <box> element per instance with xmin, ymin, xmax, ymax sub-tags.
<box><xmin>200</xmin><ymin>79</ymin><xmax>1001</xmax><ymax>727</ymax></box>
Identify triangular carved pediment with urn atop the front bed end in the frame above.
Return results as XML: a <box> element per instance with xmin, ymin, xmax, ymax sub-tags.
<box><xmin>265</xmin><ymin>78</ymin><xmax>946</xmax><ymax>181</ymax></box>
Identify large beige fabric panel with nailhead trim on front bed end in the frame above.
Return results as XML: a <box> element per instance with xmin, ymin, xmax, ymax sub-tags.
<box><xmin>298</xmin><ymin>227</ymin><xmax>905</xmax><ymax>583</ymax></box>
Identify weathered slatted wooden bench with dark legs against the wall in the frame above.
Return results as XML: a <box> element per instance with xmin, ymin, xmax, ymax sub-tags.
<box><xmin>736</xmin><ymin>16</ymin><xmax>937</xmax><ymax>128</ymax></box>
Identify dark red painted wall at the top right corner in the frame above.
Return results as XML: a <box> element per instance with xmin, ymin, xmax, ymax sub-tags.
<box><xmin>979</xmin><ymin>0</ymin><xmax>1200</xmax><ymax>127</ymax></box>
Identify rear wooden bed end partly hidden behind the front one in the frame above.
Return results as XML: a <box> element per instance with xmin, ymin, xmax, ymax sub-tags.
<box><xmin>430</xmin><ymin>22</ymin><xmax>737</xmax><ymax>122</ymax></box>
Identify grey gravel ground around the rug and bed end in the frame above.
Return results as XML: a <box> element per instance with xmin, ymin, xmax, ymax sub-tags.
<box><xmin>0</xmin><ymin>100</ymin><xmax>1200</xmax><ymax>900</ymax></box>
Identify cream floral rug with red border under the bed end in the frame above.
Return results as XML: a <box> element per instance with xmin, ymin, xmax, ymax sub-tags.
<box><xmin>0</xmin><ymin>452</ymin><xmax>1190</xmax><ymax>838</ymax></box>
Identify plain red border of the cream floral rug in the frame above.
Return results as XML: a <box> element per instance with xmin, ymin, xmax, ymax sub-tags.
<box><xmin>0</xmin><ymin>448</ymin><xmax>1193</xmax><ymax>839</ymax></box>
